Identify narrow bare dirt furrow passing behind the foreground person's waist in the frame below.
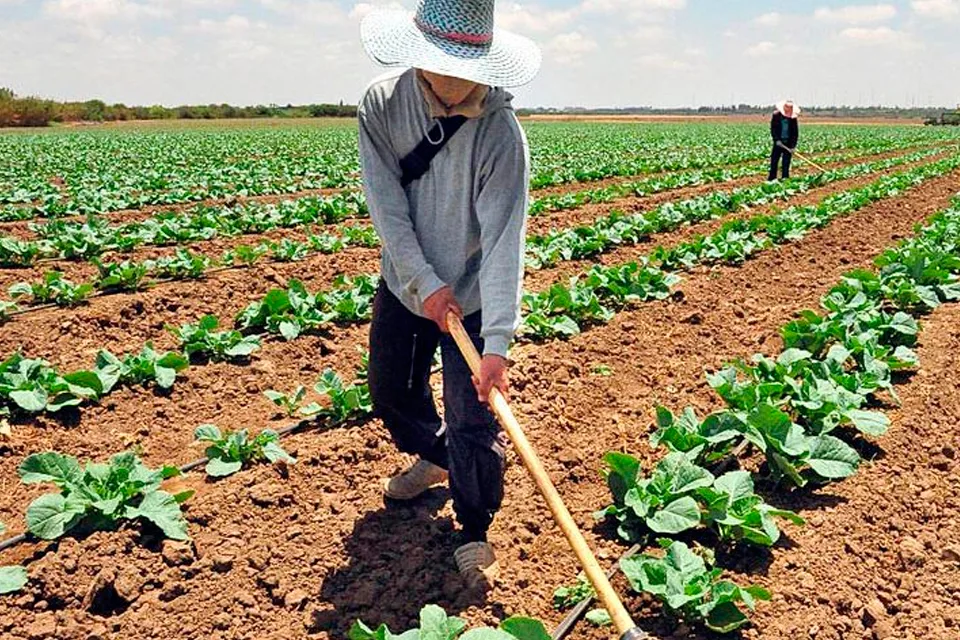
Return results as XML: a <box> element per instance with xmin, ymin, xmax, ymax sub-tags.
<box><xmin>0</xmin><ymin>148</ymin><xmax>948</xmax><ymax>368</ymax></box>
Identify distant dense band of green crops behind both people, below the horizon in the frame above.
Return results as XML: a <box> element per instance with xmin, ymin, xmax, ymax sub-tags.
<box><xmin>0</xmin><ymin>123</ymin><xmax>955</xmax><ymax>220</ymax></box>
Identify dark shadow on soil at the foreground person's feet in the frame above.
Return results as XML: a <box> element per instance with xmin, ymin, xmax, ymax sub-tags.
<box><xmin>310</xmin><ymin>489</ymin><xmax>496</xmax><ymax>637</ymax></box>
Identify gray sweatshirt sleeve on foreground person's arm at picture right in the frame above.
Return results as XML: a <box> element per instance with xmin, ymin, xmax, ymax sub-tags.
<box><xmin>476</xmin><ymin>113</ymin><xmax>530</xmax><ymax>357</ymax></box>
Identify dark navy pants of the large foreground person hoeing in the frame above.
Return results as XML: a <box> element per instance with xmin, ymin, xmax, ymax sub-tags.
<box><xmin>369</xmin><ymin>282</ymin><xmax>506</xmax><ymax>542</ymax></box>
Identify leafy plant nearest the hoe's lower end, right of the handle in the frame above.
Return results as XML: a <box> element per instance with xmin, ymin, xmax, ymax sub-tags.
<box><xmin>620</xmin><ymin>542</ymin><xmax>770</xmax><ymax>633</ymax></box>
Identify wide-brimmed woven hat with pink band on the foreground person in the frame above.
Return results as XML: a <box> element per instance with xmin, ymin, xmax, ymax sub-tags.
<box><xmin>360</xmin><ymin>0</ymin><xmax>540</xmax><ymax>87</ymax></box>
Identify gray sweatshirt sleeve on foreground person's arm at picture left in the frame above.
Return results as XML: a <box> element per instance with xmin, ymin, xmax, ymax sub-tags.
<box><xmin>359</xmin><ymin>92</ymin><xmax>446</xmax><ymax>302</ymax></box>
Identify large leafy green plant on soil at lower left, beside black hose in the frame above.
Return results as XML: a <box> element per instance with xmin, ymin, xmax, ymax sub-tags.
<box><xmin>18</xmin><ymin>451</ymin><xmax>193</xmax><ymax>540</ymax></box>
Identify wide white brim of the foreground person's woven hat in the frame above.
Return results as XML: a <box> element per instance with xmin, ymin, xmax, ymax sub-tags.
<box><xmin>360</xmin><ymin>10</ymin><xmax>541</xmax><ymax>87</ymax></box>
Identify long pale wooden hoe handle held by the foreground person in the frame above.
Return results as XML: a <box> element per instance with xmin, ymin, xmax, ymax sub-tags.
<box><xmin>447</xmin><ymin>313</ymin><xmax>649</xmax><ymax>640</ymax></box>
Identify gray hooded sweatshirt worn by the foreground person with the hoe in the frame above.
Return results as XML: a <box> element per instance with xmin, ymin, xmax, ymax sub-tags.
<box><xmin>359</xmin><ymin>69</ymin><xmax>530</xmax><ymax>356</ymax></box>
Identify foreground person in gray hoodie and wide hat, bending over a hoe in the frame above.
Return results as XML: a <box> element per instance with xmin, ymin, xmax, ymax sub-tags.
<box><xmin>359</xmin><ymin>0</ymin><xmax>540</xmax><ymax>588</ymax></box>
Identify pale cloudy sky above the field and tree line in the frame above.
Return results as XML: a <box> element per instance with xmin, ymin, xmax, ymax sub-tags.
<box><xmin>0</xmin><ymin>0</ymin><xmax>960</xmax><ymax>107</ymax></box>
